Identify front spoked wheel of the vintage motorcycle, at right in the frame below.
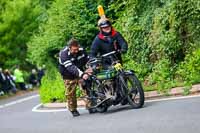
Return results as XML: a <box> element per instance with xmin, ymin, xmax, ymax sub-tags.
<box><xmin>122</xmin><ymin>73</ymin><xmax>144</xmax><ymax>109</ymax></box>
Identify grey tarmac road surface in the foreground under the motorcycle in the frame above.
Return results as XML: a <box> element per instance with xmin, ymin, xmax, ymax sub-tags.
<box><xmin>0</xmin><ymin>94</ymin><xmax>200</xmax><ymax>133</ymax></box>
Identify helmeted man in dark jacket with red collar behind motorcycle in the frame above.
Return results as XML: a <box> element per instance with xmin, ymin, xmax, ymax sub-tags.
<box><xmin>91</xmin><ymin>17</ymin><xmax>128</xmax><ymax>61</ymax></box>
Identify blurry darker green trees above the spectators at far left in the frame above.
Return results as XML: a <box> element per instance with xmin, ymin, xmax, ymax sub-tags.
<box><xmin>0</xmin><ymin>0</ymin><xmax>52</xmax><ymax>67</ymax></box>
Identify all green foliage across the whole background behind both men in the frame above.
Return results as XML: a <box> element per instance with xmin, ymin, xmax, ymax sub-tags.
<box><xmin>0</xmin><ymin>0</ymin><xmax>200</xmax><ymax>101</ymax></box>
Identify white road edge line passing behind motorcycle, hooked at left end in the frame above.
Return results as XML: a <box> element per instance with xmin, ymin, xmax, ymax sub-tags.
<box><xmin>32</xmin><ymin>95</ymin><xmax>200</xmax><ymax>113</ymax></box>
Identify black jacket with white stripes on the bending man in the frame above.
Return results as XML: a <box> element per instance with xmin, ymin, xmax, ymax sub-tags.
<box><xmin>59</xmin><ymin>47</ymin><xmax>89</xmax><ymax>79</ymax></box>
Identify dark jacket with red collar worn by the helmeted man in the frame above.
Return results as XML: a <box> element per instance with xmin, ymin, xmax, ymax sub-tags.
<box><xmin>90</xmin><ymin>29</ymin><xmax>128</xmax><ymax>57</ymax></box>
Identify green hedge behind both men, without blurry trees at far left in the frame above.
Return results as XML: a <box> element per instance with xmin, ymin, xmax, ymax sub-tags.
<box><xmin>28</xmin><ymin>0</ymin><xmax>200</xmax><ymax>102</ymax></box>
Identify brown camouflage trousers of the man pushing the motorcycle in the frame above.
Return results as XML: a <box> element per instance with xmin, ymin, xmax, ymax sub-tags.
<box><xmin>64</xmin><ymin>79</ymin><xmax>91</xmax><ymax>111</ymax></box>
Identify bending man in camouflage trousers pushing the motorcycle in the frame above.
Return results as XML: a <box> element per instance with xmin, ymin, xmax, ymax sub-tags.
<box><xmin>59</xmin><ymin>39</ymin><xmax>92</xmax><ymax>116</ymax></box>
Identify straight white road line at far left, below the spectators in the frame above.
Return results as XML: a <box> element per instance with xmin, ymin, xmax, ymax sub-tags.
<box><xmin>0</xmin><ymin>94</ymin><xmax>39</xmax><ymax>109</ymax></box>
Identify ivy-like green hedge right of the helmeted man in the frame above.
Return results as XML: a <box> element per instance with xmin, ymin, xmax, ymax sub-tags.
<box><xmin>111</xmin><ymin>0</ymin><xmax>200</xmax><ymax>92</ymax></box>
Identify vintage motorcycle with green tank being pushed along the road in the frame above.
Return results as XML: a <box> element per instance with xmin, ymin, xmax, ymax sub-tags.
<box><xmin>86</xmin><ymin>51</ymin><xmax>144</xmax><ymax>113</ymax></box>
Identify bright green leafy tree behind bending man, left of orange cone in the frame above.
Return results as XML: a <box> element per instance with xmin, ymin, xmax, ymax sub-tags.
<box><xmin>28</xmin><ymin>0</ymin><xmax>99</xmax><ymax>64</ymax></box>
